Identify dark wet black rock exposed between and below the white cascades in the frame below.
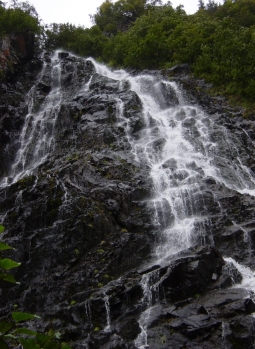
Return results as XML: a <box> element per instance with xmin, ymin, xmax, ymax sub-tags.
<box><xmin>0</xmin><ymin>53</ymin><xmax>255</xmax><ymax>349</ymax></box>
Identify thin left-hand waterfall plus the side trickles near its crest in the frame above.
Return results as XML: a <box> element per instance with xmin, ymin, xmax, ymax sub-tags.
<box><xmin>0</xmin><ymin>51</ymin><xmax>92</xmax><ymax>187</ymax></box>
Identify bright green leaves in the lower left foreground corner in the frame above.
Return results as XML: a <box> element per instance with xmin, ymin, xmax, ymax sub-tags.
<box><xmin>0</xmin><ymin>225</ymin><xmax>71</xmax><ymax>349</ymax></box>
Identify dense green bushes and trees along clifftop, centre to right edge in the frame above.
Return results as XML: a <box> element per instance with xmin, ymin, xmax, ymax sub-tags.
<box><xmin>43</xmin><ymin>0</ymin><xmax>255</xmax><ymax>106</ymax></box>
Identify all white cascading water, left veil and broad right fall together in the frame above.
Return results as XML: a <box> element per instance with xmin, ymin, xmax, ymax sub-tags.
<box><xmin>2</xmin><ymin>53</ymin><xmax>255</xmax><ymax>349</ymax></box>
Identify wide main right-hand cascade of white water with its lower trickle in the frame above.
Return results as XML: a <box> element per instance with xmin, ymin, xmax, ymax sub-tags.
<box><xmin>88</xmin><ymin>61</ymin><xmax>255</xmax><ymax>349</ymax></box>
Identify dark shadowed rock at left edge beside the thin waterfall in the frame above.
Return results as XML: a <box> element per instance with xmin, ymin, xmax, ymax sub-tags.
<box><xmin>0</xmin><ymin>33</ymin><xmax>42</xmax><ymax>176</ymax></box>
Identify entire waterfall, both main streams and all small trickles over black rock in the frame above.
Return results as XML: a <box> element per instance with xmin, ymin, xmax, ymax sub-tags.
<box><xmin>1</xmin><ymin>52</ymin><xmax>255</xmax><ymax>349</ymax></box>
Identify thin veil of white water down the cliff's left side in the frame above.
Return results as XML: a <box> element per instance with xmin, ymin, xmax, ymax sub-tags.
<box><xmin>1</xmin><ymin>52</ymin><xmax>62</xmax><ymax>182</ymax></box>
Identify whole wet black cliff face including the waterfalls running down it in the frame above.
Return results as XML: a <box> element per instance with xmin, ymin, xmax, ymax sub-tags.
<box><xmin>0</xmin><ymin>52</ymin><xmax>255</xmax><ymax>349</ymax></box>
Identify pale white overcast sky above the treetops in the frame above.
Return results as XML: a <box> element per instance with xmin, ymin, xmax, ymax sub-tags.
<box><xmin>4</xmin><ymin>0</ymin><xmax>221</xmax><ymax>27</ymax></box>
